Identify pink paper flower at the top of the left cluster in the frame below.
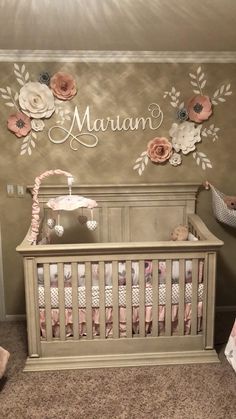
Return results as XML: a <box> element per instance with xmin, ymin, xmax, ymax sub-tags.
<box><xmin>50</xmin><ymin>72</ymin><xmax>77</xmax><ymax>100</ymax></box>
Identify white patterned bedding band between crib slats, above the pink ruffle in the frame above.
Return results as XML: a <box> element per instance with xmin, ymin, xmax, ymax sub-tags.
<box><xmin>38</xmin><ymin>283</ymin><xmax>203</xmax><ymax>308</ymax></box>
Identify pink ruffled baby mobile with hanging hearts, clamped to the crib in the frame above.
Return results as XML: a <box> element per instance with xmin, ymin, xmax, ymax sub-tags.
<box><xmin>28</xmin><ymin>169</ymin><xmax>97</xmax><ymax>244</ymax></box>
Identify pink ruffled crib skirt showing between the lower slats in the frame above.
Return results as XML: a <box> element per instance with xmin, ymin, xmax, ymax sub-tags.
<box><xmin>40</xmin><ymin>302</ymin><xmax>202</xmax><ymax>338</ymax></box>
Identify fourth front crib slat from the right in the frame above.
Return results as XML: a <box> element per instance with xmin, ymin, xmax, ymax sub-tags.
<box><xmin>152</xmin><ymin>260</ymin><xmax>159</xmax><ymax>336</ymax></box>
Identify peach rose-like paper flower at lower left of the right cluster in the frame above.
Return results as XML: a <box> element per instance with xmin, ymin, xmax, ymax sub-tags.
<box><xmin>147</xmin><ymin>137</ymin><xmax>172</xmax><ymax>163</ymax></box>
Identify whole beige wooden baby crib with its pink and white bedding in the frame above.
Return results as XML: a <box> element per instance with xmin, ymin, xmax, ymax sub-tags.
<box><xmin>17</xmin><ymin>183</ymin><xmax>223</xmax><ymax>371</ymax></box>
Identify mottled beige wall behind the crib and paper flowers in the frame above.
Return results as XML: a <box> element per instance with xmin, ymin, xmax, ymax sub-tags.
<box><xmin>0</xmin><ymin>63</ymin><xmax>236</xmax><ymax>314</ymax></box>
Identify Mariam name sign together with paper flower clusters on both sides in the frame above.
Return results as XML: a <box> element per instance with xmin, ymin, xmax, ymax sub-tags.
<box><xmin>0</xmin><ymin>63</ymin><xmax>232</xmax><ymax>176</ymax></box>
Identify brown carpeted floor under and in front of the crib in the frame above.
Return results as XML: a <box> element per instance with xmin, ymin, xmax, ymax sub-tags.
<box><xmin>0</xmin><ymin>322</ymin><xmax>236</xmax><ymax>419</ymax></box>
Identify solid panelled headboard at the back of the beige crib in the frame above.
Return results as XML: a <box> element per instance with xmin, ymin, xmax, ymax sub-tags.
<box><xmin>28</xmin><ymin>183</ymin><xmax>200</xmax><ymax>243</ymax></box>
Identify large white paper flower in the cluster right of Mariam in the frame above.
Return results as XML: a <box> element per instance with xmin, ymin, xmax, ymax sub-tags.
<box><xmin>169</xmin><ymin>121</ymin><xmax>202</xmax><ymax>154</ymax></box>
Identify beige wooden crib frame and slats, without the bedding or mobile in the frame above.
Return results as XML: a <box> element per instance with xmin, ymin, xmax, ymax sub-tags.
<box><xmin>17</xmin><ymin>183</ymin><xmax>223</xmax><ymax>371</ymax></box>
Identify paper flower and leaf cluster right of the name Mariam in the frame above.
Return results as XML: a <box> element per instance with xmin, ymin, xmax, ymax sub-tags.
<box><xmin>133</xmin><ymin>67</ymin><xmax>232</xmax><ymax>176</ymax></box>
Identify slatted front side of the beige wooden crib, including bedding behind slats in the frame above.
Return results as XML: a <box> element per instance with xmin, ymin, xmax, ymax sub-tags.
<box><xmin>19</xmin><ymin>240</ymin><xmax>219</xmax><ymax>371</ymax></box>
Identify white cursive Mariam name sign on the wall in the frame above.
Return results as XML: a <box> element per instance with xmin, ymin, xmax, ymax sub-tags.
<box><xmin>48</xmin><ymin>103</ymin><xmax>163</xmax><ymax>151</ymax></box>
